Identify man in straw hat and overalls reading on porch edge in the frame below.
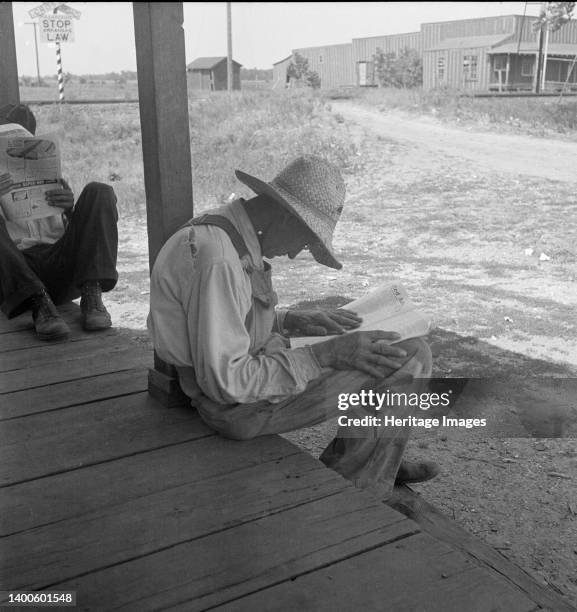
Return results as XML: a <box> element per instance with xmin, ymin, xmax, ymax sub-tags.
<box><xmin>148</xmin><ymin>156</ymin><xmax>437</xmax><ymax>491</ymax></box>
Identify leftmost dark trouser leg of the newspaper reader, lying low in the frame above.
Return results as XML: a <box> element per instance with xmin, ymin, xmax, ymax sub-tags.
<box><xmin>0</xmin><ymin>216</ymin><xmax>44</xmax><ymax>318</ymax></box>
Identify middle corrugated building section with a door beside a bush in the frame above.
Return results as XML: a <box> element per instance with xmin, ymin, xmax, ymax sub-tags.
<box><xmin>353</xmin><ymin>32</ymin><xmax>422</xmax><ymax>87</ymax></box>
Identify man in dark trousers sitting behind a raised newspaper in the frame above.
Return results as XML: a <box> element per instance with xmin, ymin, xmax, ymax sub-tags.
<box><xmin>0</xmin><ymin>105</ymin><xmax>118</xmax><ymax>340</ymax></box>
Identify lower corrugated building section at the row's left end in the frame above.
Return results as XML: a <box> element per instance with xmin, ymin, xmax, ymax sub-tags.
<box><xmin>293</xmin><ymin>43</ymin><xmax>356</xmax><ymax>89</ymax></box>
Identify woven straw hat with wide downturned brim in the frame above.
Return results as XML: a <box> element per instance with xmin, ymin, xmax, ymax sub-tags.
<box><xmin>236</xmin><ymin>155</ymin><xmax>345</xmax><ymax>270</ymax></box>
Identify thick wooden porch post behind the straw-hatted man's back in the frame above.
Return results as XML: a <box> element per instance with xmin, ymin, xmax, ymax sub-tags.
<box><xmin>133</xmin><ymin>2</ymin><xmax>193</xmax><ymax>406</ymax></box>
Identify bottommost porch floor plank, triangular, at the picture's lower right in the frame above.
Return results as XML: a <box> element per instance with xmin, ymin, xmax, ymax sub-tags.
<box><xmin>214</xmin><ymin>534</ymin><xmax>535</xmax><ymax>612</ymax></box>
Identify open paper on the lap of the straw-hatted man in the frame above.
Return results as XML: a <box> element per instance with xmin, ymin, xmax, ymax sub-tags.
<box><xmin>290</xmin><ymin>282</ymin><xmax>432</xmax><ymax>348</ymax></box>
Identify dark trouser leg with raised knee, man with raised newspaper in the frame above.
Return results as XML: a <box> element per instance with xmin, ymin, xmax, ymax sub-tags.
<box><xmin>24</xmin><ymin>183</ymin><xmax>118</xmax><ymax>304</ymax></box>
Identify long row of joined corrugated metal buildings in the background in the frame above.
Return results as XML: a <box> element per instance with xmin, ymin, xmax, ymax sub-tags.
<box><xmin>275</xmin><ymin>15</ymin><xmax>577</xmax><ymax>91</ymax></box>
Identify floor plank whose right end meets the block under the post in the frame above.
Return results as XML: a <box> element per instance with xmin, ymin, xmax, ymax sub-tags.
<box><xmin>0</xmin><ymin>393</ymin><xmax>213</xmax><ymax>486</ymax></box>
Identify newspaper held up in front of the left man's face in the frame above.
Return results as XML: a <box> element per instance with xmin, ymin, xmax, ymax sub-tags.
<box><xmin>0</xmin><ymin>123</ymin><xmax>62</xmax><ymax>222</ymax></box>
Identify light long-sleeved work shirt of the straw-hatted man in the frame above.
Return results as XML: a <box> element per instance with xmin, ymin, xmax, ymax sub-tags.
<box><xmin>148</xmin><ymin>200</ymin><xmax>321</xmax><ymax>404</ymax></box>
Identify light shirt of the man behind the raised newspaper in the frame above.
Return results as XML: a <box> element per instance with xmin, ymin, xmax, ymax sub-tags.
<box><xmin>0</xmin><ymin>123</ymin><xmax>66</xmax><ymax>251</ymax></box>
